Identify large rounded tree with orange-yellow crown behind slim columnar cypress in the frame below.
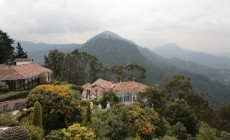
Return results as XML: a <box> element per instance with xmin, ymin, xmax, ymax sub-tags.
<box><xmin>26</xmin><ymin>85</ymin><xmax>72</xmax><ymax>130</ymax></box>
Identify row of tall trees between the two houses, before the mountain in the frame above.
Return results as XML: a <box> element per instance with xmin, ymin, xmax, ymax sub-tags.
<box><xmin>44</xmin><ymin>49</ymin><xmax>146</xmax><ymax>85</ymax></box>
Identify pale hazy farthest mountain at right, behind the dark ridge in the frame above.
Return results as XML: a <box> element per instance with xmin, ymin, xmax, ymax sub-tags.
<box><xmin>152</xmin><ymin>43</ymin><xmax>230</xmax><ymax>70</ymax></box>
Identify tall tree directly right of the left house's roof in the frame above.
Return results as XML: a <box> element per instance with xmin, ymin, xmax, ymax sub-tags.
<box><xmin>44</xmin><ymin>49</ymin><xmax>65</xmax><ymax>78</ymax></box>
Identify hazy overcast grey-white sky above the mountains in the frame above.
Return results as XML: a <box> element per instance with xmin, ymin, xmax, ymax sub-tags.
<box><xmin>0</xmin><ymin>0</ymin><xmax>230</xmax><ymax>52</ymax></box>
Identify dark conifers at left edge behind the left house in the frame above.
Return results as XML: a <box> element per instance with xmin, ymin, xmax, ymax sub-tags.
<box><xmin>0</xmin><ymin>30</ymin><xmax>27</xmax><ymax>64</ymax></box>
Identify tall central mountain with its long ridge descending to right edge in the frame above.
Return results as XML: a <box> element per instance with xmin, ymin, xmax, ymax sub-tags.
<box><xmin>80</xmin><ymin>32</ymin><xmax>230</xmax><ymax>105</ymax></box>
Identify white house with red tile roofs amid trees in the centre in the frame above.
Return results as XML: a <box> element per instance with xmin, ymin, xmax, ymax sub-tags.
<box><xmin>82</xmin><ymin>79</ymin><xmax>148</xmax><ymax>104</ymax></box>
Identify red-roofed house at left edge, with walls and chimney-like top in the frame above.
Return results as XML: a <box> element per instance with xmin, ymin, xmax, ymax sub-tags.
<box><xmin>0</xmin><ymin>58</ymin><xmax>52</xmax><ymax>90</ymax></box>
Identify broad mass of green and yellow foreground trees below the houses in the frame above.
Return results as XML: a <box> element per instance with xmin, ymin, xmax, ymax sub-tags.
<box><xmin>2</xmin><ymin>74</ymin><xmax>230</xmax><ymax>140</ymax></box>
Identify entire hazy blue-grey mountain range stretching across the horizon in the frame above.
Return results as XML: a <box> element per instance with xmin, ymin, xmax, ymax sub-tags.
<box><xmin>17</xmin><ymin>31</ymin><xmax>230</xmax><ymax>105</ymax></box>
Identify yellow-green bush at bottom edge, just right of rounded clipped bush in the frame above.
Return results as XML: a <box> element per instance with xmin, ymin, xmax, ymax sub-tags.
<box><xmin>25</xmin><ymin>125</ymin><xmax>44</xmax><ymax>140</ymax></box>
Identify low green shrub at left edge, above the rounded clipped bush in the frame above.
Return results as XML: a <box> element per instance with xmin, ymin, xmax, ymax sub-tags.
<box><xmin>0</xmin><ymin>113</ymin><xmax>18</xmax><ymax>126</ymax></box>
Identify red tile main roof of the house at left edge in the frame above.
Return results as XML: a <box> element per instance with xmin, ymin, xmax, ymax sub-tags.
<box><xmin>0</xmin><ymin>63</ymin><xmax>52</xmax><ymax>80</ymax></box>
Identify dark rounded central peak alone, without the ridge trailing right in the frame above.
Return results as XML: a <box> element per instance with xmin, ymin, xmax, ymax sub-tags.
<box><xmin>80</xmin><ymin>31</ymin><xmax>147</xmax><ymax>67</ymax></box>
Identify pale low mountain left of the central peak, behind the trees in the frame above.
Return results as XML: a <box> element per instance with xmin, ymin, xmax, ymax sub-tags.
<box><xmin>16</xmin><ymin>41</ymin><xmax>80</xmax><ymax>65</ymax></box>
